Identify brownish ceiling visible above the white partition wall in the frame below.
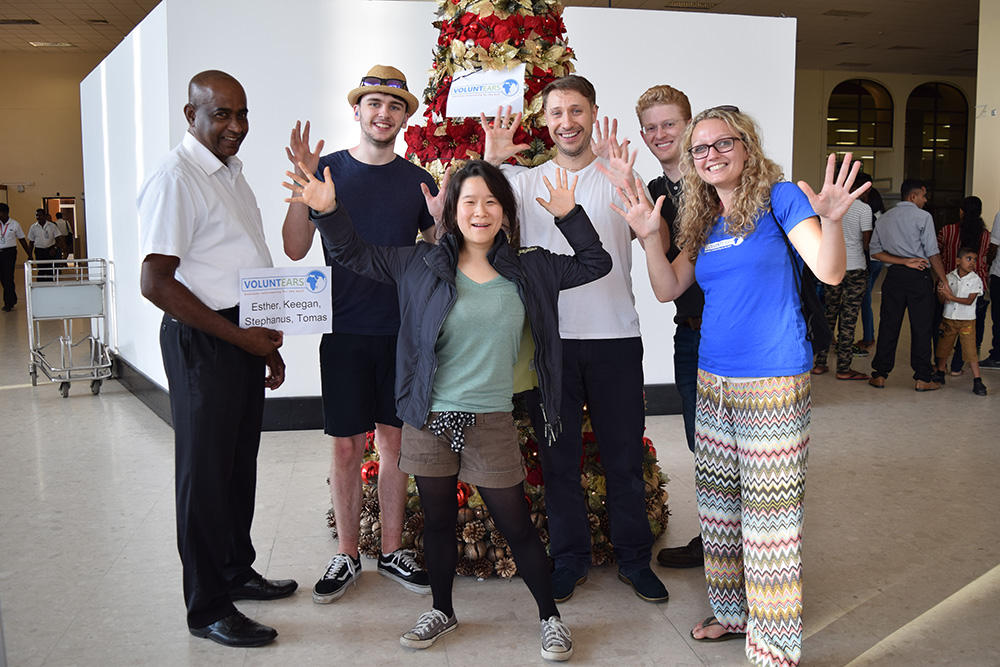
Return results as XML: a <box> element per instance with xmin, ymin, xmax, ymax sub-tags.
<box><xmin>0</xmin><ymin>0</ymin><xmax>976</xmax><ymax>76</ymax></box>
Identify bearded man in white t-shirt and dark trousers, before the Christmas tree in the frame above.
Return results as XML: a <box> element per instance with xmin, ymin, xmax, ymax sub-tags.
<box><xmin>483</xmin><ymin>75</ymin><xmax>668</xmax><ymax>602</ymax></box>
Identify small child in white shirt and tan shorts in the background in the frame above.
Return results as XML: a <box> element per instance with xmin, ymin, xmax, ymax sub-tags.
<box><xmin>932</xmin><ymin>248</ymin><xmax>986</xmax><ymax>396</ymax></box>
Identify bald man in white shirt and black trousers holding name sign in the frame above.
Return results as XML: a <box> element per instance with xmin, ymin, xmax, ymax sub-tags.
<box><xmin>138</xmin><ymin>71</ymin><xmax>297</xmax><ymax>647</ymax></box>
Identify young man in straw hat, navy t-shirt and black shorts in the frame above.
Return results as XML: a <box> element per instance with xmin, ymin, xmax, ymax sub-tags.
<box><xmin>282</xmin><ymin>65</ymin><xmax>440</xmax><ymax>604</ymax></box>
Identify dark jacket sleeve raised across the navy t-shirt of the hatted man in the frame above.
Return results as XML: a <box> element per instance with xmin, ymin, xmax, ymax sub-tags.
<box><xmin>309</xmin><ymin>204</ymin><xmax>413</xmax><ymax>284</ymax></box>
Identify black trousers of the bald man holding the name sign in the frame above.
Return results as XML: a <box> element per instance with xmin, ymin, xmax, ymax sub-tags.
<box><xmin>160</xmin><ymin>308</ymin><xmax>264</xmax><ymax>628</ymax></box>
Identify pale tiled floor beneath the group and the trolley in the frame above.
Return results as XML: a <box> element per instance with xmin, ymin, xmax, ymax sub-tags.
<box><xmin>0</xmin><ymin>272</ymin><xmax>1000</xmax><ymax>667</ymax></box>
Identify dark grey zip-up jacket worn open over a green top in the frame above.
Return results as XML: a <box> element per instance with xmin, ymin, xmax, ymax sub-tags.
<box><xmin>310</xmin><ymin>206</ymin><xmax>611</xmax><ymax>443</ymax></box>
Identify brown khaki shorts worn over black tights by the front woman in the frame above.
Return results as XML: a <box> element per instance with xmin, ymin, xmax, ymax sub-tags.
<box><xmin>399</xmin><ymin>412</ymin><xmax>525</xmax><ymax>489</ymax></box>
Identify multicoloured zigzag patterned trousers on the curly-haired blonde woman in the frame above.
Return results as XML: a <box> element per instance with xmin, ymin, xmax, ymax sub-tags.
<box><xmin>695</xmin><ymin>369</ymin><xmax>810</xmax><ymax>667</ymax></box>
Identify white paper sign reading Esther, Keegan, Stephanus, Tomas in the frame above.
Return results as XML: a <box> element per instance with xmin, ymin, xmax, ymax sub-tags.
<box><xmin>240</xmin><ymin>266</ymin><xmax>333</xmax><ymax>335</ymax></box>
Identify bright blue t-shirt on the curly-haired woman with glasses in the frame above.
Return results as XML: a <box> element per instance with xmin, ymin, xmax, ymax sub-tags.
<box><xmin>695</xmin><ymin>182</ymin><xmax>816</xmax><ymax>377</ymax></box>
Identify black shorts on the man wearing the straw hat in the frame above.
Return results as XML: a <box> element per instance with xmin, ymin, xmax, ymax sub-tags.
<box><xmin>319</xmin><ymin>333</ymin><xmax>403</xmax><ymax>438</ymax></box>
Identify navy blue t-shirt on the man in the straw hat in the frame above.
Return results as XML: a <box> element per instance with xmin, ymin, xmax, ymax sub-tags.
<box><xmin>316</xmin><ymin>150</ymin><xmax>437</xmax><ymax>336</ymax></box>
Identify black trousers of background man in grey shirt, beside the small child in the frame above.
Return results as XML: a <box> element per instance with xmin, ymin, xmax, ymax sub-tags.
<box><xmin>872</xmin><ymin>264</ymin><xmax>937</xmax><ymax>382</ymax></box>
